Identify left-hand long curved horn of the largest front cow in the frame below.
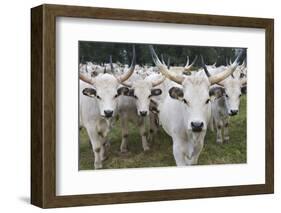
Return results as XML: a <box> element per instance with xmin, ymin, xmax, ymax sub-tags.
<box><xmin>148</xmin><ymin>45</ymin><xmax>184</xmax><ymax>84</ymax></box>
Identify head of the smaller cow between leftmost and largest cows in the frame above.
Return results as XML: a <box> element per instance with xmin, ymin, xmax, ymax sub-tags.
<box><xmin>121</xmin><ymin>73</ymin><xmax>165</xmax><ymax>117</ymax></box>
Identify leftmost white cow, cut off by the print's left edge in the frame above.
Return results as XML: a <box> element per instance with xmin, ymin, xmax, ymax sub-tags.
<box><xmin>80</xmin><ymin>47</ymin><xmax>135</xmax><ymax>169</ymax></box>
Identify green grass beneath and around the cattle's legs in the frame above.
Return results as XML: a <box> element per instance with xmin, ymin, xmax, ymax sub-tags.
<box><xmin>79</xmin><ymin>96</ymin><xmax>247</xmax><ymax>170</ymax></box>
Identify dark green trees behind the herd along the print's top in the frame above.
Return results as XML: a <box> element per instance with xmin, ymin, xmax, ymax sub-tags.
<box><xmin>79</xmin><ymin>41</ymin><xmax>246</xmax><ymax>66</ymax></box>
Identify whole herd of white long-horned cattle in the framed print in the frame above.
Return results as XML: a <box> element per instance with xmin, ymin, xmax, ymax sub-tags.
<box><xmin>79</xmin><ymin>45</ymin><xmax>247</xmax><ymax>169</ymax></box>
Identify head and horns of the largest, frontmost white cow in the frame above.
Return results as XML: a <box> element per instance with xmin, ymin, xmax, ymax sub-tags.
<box><xmin>150</xmin><ymin>46</ymin><xmax>241</xmax><ymax>132</ymax></box>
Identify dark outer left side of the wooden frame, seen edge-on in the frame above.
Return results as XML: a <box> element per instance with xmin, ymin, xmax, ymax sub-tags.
<box><xmin>30</xmin><ymin>5</ymin><xmax>44</xmax><ymax>207</ymax></box>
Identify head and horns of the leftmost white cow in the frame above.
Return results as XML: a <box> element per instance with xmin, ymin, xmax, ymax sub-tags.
<box><xmin>80</xmin><ymin>48</ymin><xmax>135</xmax><ymax>118</ymax></box>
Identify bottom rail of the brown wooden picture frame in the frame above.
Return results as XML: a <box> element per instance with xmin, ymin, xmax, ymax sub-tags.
<box><xmin>45</xmin><ymin>184</ymin><xmax>272</xmax><ymax>208</ymax></box>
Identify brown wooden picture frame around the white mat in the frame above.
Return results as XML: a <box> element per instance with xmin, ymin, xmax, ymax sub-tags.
<box><xmin>31</xmin><ymin>5</ymin><xmax>274</xmax><ymax>208</ymax></box>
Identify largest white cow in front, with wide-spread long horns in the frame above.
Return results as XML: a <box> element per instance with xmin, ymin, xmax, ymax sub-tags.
<box><xmin>150</xmin><ymin>46</ymin><xmax>241</xmax><ymax>166</ymax></box>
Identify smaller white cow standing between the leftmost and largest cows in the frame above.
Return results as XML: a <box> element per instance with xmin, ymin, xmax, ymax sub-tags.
<box><xmin>118</xmin><ymin>74</ymin><xmax>165</xmax><ymax>152</ymax></box>
